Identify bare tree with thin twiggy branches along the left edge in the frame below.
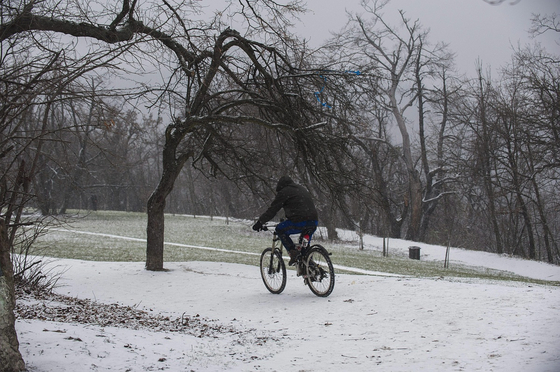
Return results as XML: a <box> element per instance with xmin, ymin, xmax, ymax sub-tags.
<box><xmin>0</xmin><ymin>2</ymin><xmax>136</xmax><ymax>371</ymax></box>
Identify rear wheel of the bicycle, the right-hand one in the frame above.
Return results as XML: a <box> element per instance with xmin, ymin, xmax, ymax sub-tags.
<box><xmin>305</xmin><ymin>245</ymin><xmax>334</xmax><ymax>297</ymax></box>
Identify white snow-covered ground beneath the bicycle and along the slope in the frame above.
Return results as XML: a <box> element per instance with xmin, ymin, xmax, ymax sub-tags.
<box><xmin>16</xmin><ymin>238</ymin><xmax>560</xmax><ymax>372</ymax></box>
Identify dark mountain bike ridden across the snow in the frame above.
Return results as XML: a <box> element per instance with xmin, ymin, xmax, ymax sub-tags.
<box><xmin>260</xmin><ymin>225</ymin><xmax>335</xmax><ymax>297</ymax></box>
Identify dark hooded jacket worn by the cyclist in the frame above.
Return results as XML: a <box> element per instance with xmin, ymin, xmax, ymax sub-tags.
<box><xmin>259</xmin><ymin>176</ymin><xmax>318</xmax><ymax>223</ymax></box>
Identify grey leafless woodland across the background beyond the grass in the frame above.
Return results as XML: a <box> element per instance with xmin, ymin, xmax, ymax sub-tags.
<box><xmin>0</xmin><ymin>1</ymin><xmax>560</xmax><ymax>263</ymax></box>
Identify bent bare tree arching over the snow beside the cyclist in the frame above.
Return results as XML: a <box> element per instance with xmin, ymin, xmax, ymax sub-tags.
<box><xmin>0</xmin><ymin>0</ymin><xmax>344</xmax><ymax>270</ymax></box>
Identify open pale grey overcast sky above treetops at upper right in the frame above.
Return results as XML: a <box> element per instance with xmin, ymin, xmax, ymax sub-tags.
<box><xmin>296</xmin><ymin>0</ymin><xmax>560</xmax><ymax>75</ymax></box>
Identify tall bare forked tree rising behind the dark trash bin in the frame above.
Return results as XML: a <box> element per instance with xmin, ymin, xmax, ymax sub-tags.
<box><xmin>335</xmin><ymin>1</ymin><xmax>452</xmax><ymax>240</ymax></box>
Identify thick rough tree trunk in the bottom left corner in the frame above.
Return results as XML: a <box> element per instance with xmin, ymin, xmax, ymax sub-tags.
<box><xmin>0</xmin><ymin>219</ymin><xmax>25</xmax><ymax>372</ymax></box>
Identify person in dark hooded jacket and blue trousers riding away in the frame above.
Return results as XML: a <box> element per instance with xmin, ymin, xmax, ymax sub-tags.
<box><xmin>253</xmin><ymin>176</ymin><xmax>318</xmax><ymax>265</ymax></box>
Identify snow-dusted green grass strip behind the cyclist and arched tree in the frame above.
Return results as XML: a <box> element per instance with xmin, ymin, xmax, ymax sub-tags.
<box><xmin>34</xmin><ymin>211</ymin><xmax>558</xmax><ymax>285</ymax></box>
